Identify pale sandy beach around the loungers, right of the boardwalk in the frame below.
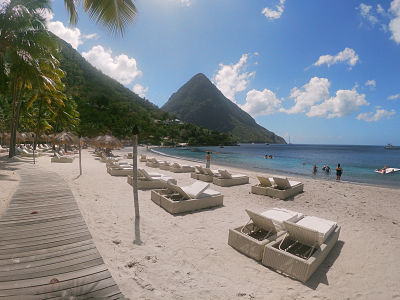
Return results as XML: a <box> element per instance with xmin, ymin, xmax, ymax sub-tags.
<box><xmin>0</xmin><ymin>148</ymin><xmax>400</xmax><ymax>299</ymax></box>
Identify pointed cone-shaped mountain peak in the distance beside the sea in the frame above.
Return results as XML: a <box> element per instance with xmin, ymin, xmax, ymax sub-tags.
<box><xmin>161</xmin><ymin>73</ymin><xmax>286</xmax><ymax>144</ymax></box>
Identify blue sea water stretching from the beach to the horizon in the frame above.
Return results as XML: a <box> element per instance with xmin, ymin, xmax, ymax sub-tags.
<box><xmin>152</xmin><ymin>144</ymin><xmax>400</xmax><ymax>188</ymax></box>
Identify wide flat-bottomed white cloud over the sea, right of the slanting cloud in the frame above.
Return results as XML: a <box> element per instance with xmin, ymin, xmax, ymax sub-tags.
<box><xmin>306</xmin><ymin>89</ymin><xmax>369</xmax><ymax>119</ymax></box>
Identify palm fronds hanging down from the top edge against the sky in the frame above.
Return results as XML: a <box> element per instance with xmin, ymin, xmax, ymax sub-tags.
<box><xmin>64</xmin><ymin>0</ymin><xmax>136</xmax><ymax>35</ymax></box>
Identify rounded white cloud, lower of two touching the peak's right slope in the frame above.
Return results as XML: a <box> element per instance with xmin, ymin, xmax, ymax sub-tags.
<box><xmin>239</xmin><ymin>89</ymin><xmax>281</xmax><ymax>117</ymax></box>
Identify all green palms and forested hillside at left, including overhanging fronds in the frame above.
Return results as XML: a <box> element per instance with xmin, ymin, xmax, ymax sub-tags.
<box><xmin>0</xmin><ymin>0</ymin><xmax>235</xmax><ymax>157</ymax></box>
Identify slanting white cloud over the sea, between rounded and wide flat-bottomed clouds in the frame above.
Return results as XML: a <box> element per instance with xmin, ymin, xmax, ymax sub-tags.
<box><xmin>281</xmin><ymin>77</ymin><xmax>331</xmax><ymax>114</ymax></box>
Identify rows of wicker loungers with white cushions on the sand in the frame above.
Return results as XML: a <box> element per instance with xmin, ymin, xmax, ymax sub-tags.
<box><xmin>92</xmin><ymin>151</ymin><xmax>341</xmax><ymax>282</ymax></box>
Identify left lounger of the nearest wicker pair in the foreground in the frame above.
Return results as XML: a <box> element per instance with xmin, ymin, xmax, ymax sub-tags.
<box><xmin>228</xmin><ymin>208</ymin><xmax>303</xmax><ymax>261</ymax></box>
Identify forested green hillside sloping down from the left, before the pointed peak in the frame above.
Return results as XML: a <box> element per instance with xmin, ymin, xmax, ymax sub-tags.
<box><xmin>59</xmin><ymin>39</ymin><xmax>235</xmax><ymax>145</ymax></box>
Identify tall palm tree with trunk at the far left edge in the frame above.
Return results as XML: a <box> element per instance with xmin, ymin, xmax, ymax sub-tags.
<box><xmin>0</xmin><ymin>0</ymin><xmax>58</xmax><ymax>157</ymax></box>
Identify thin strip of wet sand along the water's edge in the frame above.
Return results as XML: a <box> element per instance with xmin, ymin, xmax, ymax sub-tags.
<box><xmin>148</xmin><ymin>146</ymin><xmax>400</xmax><ymax>190</ymax></box>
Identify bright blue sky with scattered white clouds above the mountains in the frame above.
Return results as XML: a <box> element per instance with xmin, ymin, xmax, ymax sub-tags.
<box><xmin>48</xmin><ymin>0</ymin><xmax>400</xmax><ymax>145</ymax></box>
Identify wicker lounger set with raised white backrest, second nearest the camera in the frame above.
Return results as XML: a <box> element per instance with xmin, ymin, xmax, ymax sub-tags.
<box><xmin>151</xmin><ymin>181</ymin><xmax>224</xmax><ymax>214</ymax></box>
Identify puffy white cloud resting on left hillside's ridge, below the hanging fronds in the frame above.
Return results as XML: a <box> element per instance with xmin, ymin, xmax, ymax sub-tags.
<box><xmin>82</xmin><ymin>45</ymin><xmax>142</xmax><ymax>84</ymax></box>
